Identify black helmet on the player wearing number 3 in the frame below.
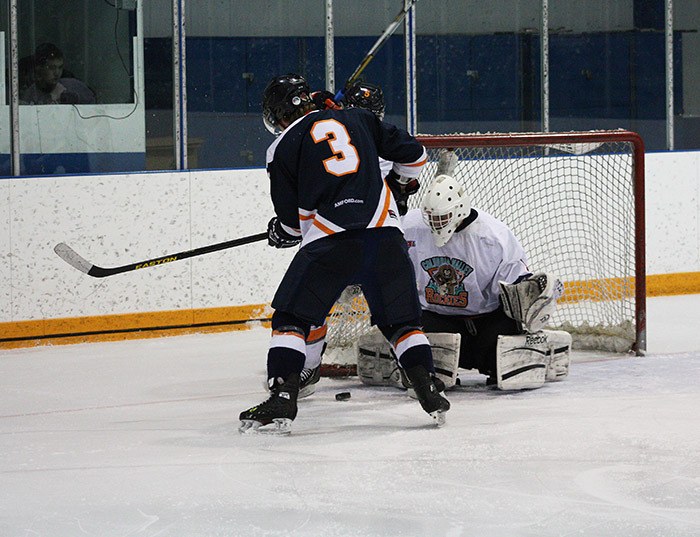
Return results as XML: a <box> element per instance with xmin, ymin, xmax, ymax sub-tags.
<box><xmin>263</xmin><ymin>73</ymin><xmax>311</xmax><ymax>135</ymax></box>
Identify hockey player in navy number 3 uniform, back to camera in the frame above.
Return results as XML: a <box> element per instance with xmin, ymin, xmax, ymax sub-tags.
<box><xmin>240</xmin><ymin>74</ymin><xmax>450</xmax><ymax>434</ymax></box>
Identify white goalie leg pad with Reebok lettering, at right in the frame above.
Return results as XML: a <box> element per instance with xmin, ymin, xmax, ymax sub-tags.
<box><xmin>496</xmin><ymin>330</ymin><xmax>571</xmax><ymax>390</ymax></box>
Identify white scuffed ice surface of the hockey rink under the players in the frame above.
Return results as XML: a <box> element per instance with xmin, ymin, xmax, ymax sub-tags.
<box><xmin>0</xmin><ymin>295</ymin><xmax>700</xmax><ymax>537</ymax></box>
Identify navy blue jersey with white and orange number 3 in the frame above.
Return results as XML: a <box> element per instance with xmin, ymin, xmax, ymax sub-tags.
<box><xmin>267</xmin><ymin>108</ymin><xmax>427</xmax><ymax>246</ymax></box>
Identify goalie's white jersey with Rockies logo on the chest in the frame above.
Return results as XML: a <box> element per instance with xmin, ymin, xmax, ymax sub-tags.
<box><xmin>402</xmin><ymin>204</ymin><xmax>531</xmax><ymax>316</ymax></box>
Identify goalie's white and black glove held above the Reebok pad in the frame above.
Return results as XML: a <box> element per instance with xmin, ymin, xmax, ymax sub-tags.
<box><xmin>499</xmin><ymin>272</ymin><xmax>564</xmax><ymax>333</ymax></box>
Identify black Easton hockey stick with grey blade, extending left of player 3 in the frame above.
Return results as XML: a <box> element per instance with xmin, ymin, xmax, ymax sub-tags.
<box><xmin>53</xmin><ymin>232</ymin><xmax>267</xmax><ymax>278</ymax></box>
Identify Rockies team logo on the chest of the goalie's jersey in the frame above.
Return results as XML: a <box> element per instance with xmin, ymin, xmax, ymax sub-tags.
<box><xmin>421</xmin><ymin>256</ymin><xmax>474</xmax><ymax>308</ymax></box>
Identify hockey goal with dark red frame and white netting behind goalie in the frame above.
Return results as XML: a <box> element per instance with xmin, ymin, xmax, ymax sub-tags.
<box><xmin>324</xmin><ymin>130</ymin><xmax>646</xmax><ymax>371</ymax></box>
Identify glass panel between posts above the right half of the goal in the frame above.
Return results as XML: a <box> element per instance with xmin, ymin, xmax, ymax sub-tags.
<box><xmin>549</xmin><ymin>0</ymin><xmax>666</xmax><ymax>149</ymax></box>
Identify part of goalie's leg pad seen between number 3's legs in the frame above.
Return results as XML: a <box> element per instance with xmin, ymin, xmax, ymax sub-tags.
<box><xmin>357</xmin><ymin>331</ymin><xmax>406</xmax><ymax>388</ymax></box>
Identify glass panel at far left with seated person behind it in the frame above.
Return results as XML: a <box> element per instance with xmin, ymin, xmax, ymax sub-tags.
<box><xmin>18</xmin><ymin>0</ymin><xmax>145</xmax><ymax>175</ymax></box>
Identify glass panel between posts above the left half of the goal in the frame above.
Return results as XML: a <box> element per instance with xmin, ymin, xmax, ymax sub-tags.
<box><xmin>416</xmin><ymin>0</ymin><xmax>541</xmax><ymax>134</ymax></box>
